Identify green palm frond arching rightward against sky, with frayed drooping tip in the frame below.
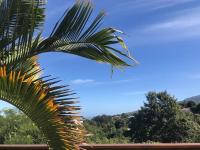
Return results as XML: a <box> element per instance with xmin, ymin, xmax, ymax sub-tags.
<box><xmin>34</xmin><ymin>1</ymin><xmax>136</xmax><ymax>67</ymax></box>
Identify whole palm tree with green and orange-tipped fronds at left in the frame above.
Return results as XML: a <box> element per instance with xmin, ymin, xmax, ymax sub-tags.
<box><xmin>0</xmin><ymin>0</ymin><xmax>134</xmax><ymax>150</ymax></box>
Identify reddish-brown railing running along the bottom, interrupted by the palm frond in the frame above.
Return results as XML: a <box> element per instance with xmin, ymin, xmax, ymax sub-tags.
<box><xmin>0</xmin><ymin>143</ymin><xmax>200</xmax><ymax>150</ymax></box>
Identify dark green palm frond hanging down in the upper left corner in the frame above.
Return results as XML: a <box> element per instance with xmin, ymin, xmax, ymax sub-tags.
<box><xmin>0</xmin><ymin>0</ymin><xmax>45</xmax><ymax>64</ymax></box>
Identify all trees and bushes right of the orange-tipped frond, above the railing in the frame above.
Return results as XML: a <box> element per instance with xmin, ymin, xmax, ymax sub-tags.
<box><xmin>85</xmin><ymin>92</ymin><xmax>200</xmax><ymax>143</ymax></box>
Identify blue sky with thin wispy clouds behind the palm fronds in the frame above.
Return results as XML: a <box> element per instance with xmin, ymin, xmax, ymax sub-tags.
<box><xmin>1</xmin><ymin>0</ymin><xmax>200</xmax><ymax>117</ymax></box>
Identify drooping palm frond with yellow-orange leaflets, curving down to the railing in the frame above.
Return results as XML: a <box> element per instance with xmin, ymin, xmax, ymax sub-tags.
<box><xmin>0</xmin><ymin>67</ymin><xmax>83</xmax><ymax>150</ymax></box>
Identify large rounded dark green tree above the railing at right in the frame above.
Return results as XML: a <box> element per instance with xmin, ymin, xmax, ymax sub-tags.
<box><xmin>129</xmin><ymin>92</ymin><xmax>200</xmax><ymax>143</ymax></box>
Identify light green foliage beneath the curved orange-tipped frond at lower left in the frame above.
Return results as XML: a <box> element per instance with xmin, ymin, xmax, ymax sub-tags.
<box><xmin>0</xmin><ymin>109</ymin><xmax>46</xmax><ymax>144</ymax></box>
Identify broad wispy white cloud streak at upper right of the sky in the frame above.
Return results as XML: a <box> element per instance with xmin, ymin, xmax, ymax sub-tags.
<box><xmin>131</xmin><ymin>7</ymin><xmax>200</xmax><ymax>44</ymax></box>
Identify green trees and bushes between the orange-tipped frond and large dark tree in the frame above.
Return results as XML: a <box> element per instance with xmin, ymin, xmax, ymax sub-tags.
<box><xmin>84</xmin><ymin>115</ymin><xmax>129</xmax><ymax>144</ymax></box>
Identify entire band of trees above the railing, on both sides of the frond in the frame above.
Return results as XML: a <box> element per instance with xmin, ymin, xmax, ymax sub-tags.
<box><xmin>0</xmin><ymin>92</ymin><xmax>200</xmax><ymax>144</ymax></box>
